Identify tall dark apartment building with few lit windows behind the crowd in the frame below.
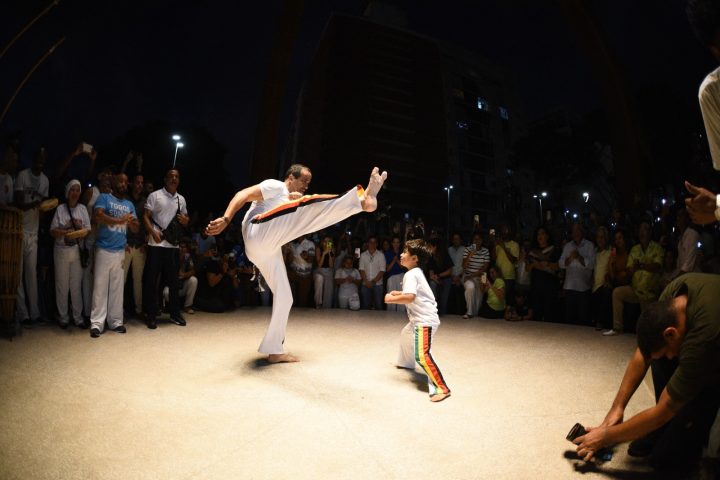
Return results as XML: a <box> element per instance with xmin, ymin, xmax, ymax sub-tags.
<box><xmin>283</xmin><ymin>15</ymin><xmax>514</xmax><ymax>233</ymax></box>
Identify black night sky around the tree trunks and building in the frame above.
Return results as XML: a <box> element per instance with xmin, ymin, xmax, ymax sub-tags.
<box><xmin>0</xmin><ymin>0</ymin><xmax>714</xmax><ymax>187</ymax></box>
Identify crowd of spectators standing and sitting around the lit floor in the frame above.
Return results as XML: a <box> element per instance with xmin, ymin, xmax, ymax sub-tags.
<box><xmin>0</xmin><ymin>144</ymin><xmax>720</xmax><ymax>336</ymax></box>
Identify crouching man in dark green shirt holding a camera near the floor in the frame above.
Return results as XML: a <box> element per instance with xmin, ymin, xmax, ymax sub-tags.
<box><xmin>574</xmin><ymin>273</ymin><xmax>720</xmax><ymax>469</ymax></box>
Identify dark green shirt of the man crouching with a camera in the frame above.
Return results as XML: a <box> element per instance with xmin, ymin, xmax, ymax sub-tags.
<box><xmin>660</xmin><ymin>273</ymin><xmax>720</xmax><ymax>402</ymax></box>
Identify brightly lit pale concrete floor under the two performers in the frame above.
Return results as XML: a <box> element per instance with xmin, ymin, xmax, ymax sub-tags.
<box><xmin>0</xmin><ymin>308</ymin><xmax>654</xmax><ymax>480</ymax></box>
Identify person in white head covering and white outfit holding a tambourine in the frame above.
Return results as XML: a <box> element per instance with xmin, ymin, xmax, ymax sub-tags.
<box><xmin>50</xmin><ymin>180</ymin><xmax>90</xmax><ymax>328</ymax></box>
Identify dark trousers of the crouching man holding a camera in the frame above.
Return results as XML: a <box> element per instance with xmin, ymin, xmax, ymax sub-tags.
<box><xmin>650</xmin><ymin>358</ymin><xmax>720</xmax><ymax>469</ymax></box>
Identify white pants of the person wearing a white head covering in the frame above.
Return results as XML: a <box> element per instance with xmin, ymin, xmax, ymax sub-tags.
<box><xmin>54</xmin><ymin>246</ymin><xmax>83</xmax><ymax>325</ymax></box>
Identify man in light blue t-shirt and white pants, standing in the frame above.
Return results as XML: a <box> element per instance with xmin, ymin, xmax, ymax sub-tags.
<box><xmin>90</xmin><ymin>173</ymin><xmax>140</xmax><ymax>338</ymax></box>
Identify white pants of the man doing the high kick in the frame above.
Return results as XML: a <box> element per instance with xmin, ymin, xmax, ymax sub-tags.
<box><xmin>243</xmin><ymin>187</ymin><xmax>362</xmax><ymax>354</ymax></box>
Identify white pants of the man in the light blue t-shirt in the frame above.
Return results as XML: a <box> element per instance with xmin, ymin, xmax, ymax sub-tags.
<box><xmin>90</xmin><ymin>248</ymin><xmax>125</xmax><ymax>332</ymax></box>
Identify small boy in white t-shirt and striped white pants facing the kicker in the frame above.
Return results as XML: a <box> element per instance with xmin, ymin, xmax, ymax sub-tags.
<box><xmin>385</xmin><ymin>239</ymin><xmax>450</xmax><ymax>402</ymax></box>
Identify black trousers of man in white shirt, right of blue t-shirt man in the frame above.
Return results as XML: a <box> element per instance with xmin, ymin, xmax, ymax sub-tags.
<box><xmin>143</xmin><ymin>245</ymin><xmax>180</xmax><ymax>316</ymax></box>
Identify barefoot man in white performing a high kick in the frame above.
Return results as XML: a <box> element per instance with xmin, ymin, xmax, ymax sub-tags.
<box><xmin>206</xmin><ymin>164</ymin><xmax>387</xmax><ymax>363</ymax></box>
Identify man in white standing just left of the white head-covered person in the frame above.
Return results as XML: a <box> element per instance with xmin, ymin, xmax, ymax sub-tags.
<box><xmin>15</xmin><ymin>148</ymin><xmax>50</xmax><ymax>327</ymax></box>
